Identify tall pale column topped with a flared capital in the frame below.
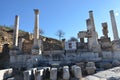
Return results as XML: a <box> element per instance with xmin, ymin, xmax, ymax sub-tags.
<box><xmin>34</xmin><ymin>9</ymin><xmax>39</xmax><ymax>46</ymax></box>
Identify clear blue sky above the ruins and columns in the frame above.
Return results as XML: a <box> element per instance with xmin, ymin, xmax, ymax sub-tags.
<box><xmin>0</xmin><ymin>0</ymin><xmax>120</xmax><ymax>39</ymax></box>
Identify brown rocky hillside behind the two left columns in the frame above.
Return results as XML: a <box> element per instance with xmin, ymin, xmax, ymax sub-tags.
<box><xmin>0</xmin><ymin>26</ymin><xmax>62</xmax><ymax>68</ymax></box>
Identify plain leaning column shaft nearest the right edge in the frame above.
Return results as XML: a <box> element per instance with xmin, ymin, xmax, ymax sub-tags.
<box><xmin>110</xmin><ymin>10</ymin><xmax>119</xmax><ymax>40</ymax></box>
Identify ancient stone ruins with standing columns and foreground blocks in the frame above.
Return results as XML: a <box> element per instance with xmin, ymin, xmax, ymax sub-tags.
<box><xmin>0</xmin><ymin>9</ymin><xmax>120</xmax><ymax>80</ymax></box>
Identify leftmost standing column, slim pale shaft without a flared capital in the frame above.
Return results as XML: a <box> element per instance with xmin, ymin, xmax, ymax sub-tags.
<box><xmin>13</xmin><ymin>15</ymin><xmax>19</xmax><ymax>46</ymax></box>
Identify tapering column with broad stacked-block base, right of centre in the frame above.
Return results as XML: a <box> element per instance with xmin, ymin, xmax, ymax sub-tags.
<box><xmin>86</xmin><ymin>17</ymin><xmax>101</xmax><ymax>52</ymax></box>
